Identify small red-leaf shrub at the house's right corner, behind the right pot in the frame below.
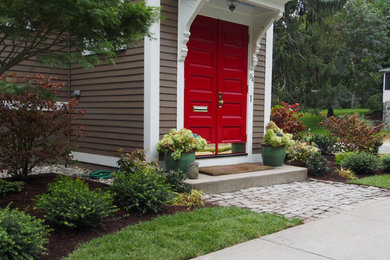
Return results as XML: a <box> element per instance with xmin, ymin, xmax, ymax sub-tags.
<box><xmin>271</xmin><ymin>101</ymin><xmax>306</xmax><ymax>135</ymax></box>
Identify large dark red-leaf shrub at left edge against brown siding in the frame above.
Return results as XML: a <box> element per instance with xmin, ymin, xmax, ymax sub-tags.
<box><xmin>0</xmin><ymin>74</ymin><xmax>85</xmax><ymax>178</ymax></box>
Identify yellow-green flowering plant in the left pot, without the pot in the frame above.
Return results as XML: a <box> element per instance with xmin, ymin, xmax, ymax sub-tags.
<box><xmin>157</xmin><ymin>128</ymin><xmax>207</xmax><ymax>160</ymax></box>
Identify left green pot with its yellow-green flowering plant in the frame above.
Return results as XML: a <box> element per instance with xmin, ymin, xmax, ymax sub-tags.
<box><xmin>157</xmin><ymin>128</ymin><xmax>207</xmax><ymax>173</ymax></box>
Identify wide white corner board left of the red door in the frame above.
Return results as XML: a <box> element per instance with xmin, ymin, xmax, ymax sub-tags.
<box><xmin>144</xmin><ymin>0</ymin><xmax>160</xmax><ymax>160</ymax></box>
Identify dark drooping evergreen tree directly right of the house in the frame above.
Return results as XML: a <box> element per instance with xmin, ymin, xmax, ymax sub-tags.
<box><xmin>273</xmin><ymin>0</ymin><xmax>345</xmax><ymax>115</ymax></box>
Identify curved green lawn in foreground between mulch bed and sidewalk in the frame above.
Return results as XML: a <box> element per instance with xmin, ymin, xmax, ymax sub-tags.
<box><xmin>66</xmin><ymin>207</ymin><xmax>302</xmax><ymax>260</ymax></box>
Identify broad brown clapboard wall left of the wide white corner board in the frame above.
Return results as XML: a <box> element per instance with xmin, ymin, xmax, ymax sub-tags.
<box><xmin>71</xmin><ymin>43</ymin><xmax>144</xmax><ymax>156</ymax></box>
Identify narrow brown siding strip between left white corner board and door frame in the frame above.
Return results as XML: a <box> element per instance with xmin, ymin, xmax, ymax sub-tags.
<box><xmin>160</xmin><ymin>0</ymin><xmax>178</xmax><ymax>136</ymax></box>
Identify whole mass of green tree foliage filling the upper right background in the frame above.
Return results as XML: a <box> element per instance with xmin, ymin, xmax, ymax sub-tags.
<box><xmin>273</xmin><ymin>0</ymin><xmax>389</xmax><ymax>115</ymax></box>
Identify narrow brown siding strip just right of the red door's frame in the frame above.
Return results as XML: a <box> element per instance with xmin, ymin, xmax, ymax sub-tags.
<box><xmin>252</xmin><ymin>39</ymin><xmax>265</xmax><ymax>154</ymax></box>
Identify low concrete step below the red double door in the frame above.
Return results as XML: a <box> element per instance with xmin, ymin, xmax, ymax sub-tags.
<box><xmin>186</xmin><ymin>165</ymin><xmax>307</xmax><ymax>194</ymax></box>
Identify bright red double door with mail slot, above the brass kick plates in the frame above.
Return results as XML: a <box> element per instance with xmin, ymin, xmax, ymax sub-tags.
<box><xmin>184</xmin><ymin>16</ymin><xmax>248</xmax><ymax>147</ymax></box>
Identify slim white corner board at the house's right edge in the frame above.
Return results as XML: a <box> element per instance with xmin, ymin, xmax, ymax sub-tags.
<box><xmin>264</xmin><ymin>25</ymin><xmax>274</xmax><ymax>133</ymax></box>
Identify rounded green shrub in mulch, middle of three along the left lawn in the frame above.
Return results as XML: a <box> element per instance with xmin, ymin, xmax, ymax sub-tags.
<box><xmin>35</xmin><ymin>176</ymin><xmax>118</xmax><ymax>228</ymax></box>
